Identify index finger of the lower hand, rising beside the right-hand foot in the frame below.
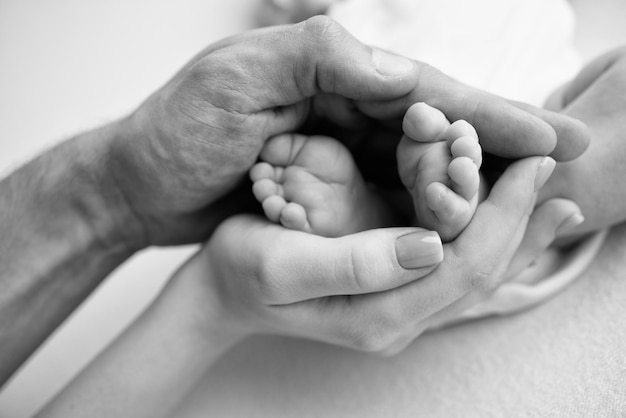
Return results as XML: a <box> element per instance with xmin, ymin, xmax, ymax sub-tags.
<box><xmin>368</xmin><ymin>157</ymin><xmax>554</xmax><ymax>320</ymax></box>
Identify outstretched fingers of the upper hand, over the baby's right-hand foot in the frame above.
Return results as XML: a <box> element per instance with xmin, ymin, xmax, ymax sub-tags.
<box><xmin>358</xmin><ymin>62</ymin><xmax>589</xmax><ymax>161</ymax></box>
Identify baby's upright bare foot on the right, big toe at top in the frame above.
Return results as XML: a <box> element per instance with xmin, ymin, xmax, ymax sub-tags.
<box><xmin>397</xmin><ymin>103</ymin><xmax>482</xmax><ymax>242</ymax></box>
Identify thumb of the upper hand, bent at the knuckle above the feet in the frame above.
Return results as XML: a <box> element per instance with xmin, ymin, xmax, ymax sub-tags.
<box><xmin>219</xmin><ymin>16</ymin><xmax>418</xmax><ymax>111</ymax></box>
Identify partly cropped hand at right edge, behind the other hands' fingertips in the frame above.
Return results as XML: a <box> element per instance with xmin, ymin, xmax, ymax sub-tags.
<box><xmin>539</xmin><ymin>48</ymin><xmax>626</xmax><ymax>237</ymax></box>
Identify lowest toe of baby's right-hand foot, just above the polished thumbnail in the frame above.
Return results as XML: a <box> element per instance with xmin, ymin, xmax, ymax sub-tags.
<box><xmin>425</xmin><ymin>183</ymin><xmax>472</xmax><ymax>242</ymax></box>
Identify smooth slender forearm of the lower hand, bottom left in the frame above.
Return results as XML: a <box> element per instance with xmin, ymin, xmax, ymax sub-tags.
<box><xmin>39</xmin><ymin>250</ymin><xmax>243</xmax><ymax>418</ymax></box>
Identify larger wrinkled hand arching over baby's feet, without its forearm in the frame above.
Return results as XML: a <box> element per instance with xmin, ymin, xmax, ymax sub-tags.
<box><xmin>109</xmin><ymin>17</ymin><xmax>586</xmax><ymax>247</ymax></box>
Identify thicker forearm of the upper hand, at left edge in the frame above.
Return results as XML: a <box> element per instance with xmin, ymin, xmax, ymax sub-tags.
<box><xmin>0</xmin><ymin>124</ymin><xmax>141</xmax><ymax>384</ymax></box>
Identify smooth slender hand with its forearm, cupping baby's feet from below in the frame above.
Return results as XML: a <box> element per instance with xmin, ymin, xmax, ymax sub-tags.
<box><xmin>39</xmin><ymin>157</ymin><xmax>584</xmax><ymax>417</ymax></box>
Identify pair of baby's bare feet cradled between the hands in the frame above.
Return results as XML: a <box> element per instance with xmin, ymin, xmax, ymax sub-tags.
<box><xmin>250</xmin><ymin>103</ymin><xmax>482</xmax><ymax>245</ymax></box>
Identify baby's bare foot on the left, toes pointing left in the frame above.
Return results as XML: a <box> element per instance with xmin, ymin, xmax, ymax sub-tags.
<box><xmin>250</xmin><ymin>134</ymin><xmax>389</xmax><ymax>237</ymax></box>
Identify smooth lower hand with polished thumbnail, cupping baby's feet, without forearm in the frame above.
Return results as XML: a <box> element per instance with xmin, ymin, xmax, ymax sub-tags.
<box><xmin>191</xmin><ymin>157</ymin><xmax>567</xmax><ymax>353</ymax></box>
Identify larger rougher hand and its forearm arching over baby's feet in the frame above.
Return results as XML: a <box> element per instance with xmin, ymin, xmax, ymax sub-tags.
<box><xmin>0</xmin><ymin>17</ymin><xmax>587</xmax><ymax>388</ymax></box>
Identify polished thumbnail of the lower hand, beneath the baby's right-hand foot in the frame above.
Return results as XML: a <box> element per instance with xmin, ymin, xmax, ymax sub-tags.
<box><xmin>396</xmin><ymin>231</ymin><xmax>443</xmax><ymax>269</ymax></box>
